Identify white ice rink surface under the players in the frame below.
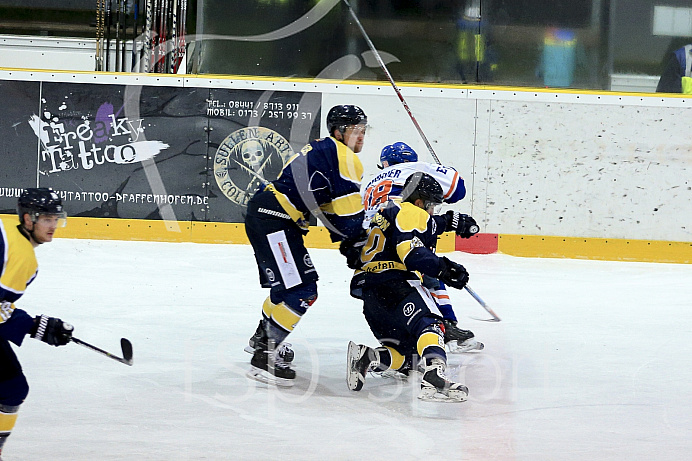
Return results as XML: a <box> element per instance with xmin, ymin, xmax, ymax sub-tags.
<box><xmin>3</xmin><ymin>239</ymin><xmax>692</xmax><ymax>461</ymax></box>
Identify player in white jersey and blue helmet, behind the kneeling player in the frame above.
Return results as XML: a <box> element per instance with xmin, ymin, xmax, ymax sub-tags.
<box><xmin>362</xmin><ymin>142</ymin><xmax>484</xmax><ymax>353</ymax></box>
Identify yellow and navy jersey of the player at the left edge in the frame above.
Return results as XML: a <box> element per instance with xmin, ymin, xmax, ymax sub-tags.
<box><xmin>0</xmin><ymin>221</ymin><xmax>38</xmax><ymax>345</ymax></box>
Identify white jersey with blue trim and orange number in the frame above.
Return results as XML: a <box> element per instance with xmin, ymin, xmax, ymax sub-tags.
<box><xmin>361</xmin><ymin>162</ymin><xmax>466</xmax><ymax>229</ymax></box>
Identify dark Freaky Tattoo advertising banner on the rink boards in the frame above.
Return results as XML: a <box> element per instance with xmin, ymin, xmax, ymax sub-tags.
<box><xmin>0</xmin><ymin>82</ymin><xmax>320</xmax><ymax>223</ymax></box>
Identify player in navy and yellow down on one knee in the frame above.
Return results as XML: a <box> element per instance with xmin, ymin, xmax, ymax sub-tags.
<box><xmin>346</xmin><ymin>172</ymin><xmax>469</xmax><ymax>402</ymax></box>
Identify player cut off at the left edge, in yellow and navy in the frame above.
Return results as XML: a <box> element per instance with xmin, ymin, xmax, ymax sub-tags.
<box><xmin>0</xmin><ymin>188</ymin><xmax>73</xmax><ymax>456</ymax></box>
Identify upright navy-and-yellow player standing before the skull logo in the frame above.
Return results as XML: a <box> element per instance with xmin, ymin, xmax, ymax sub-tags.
<box><xmin>245</xmin><ymin>105</ymin><xmax>368</xmax><ymax>386</ymax></box>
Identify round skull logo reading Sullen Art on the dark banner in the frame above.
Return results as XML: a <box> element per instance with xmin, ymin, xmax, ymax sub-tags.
<box><xmin>214</xmin><ymin>126</ymin><xmax>293</xmax><ymax>207</ymax></box>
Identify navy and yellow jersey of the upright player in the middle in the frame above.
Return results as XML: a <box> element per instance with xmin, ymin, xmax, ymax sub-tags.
<box><xmin>266</xmin><ymin>137</ymin><xmax>364</xmax><ymax>240</ymax></box>
